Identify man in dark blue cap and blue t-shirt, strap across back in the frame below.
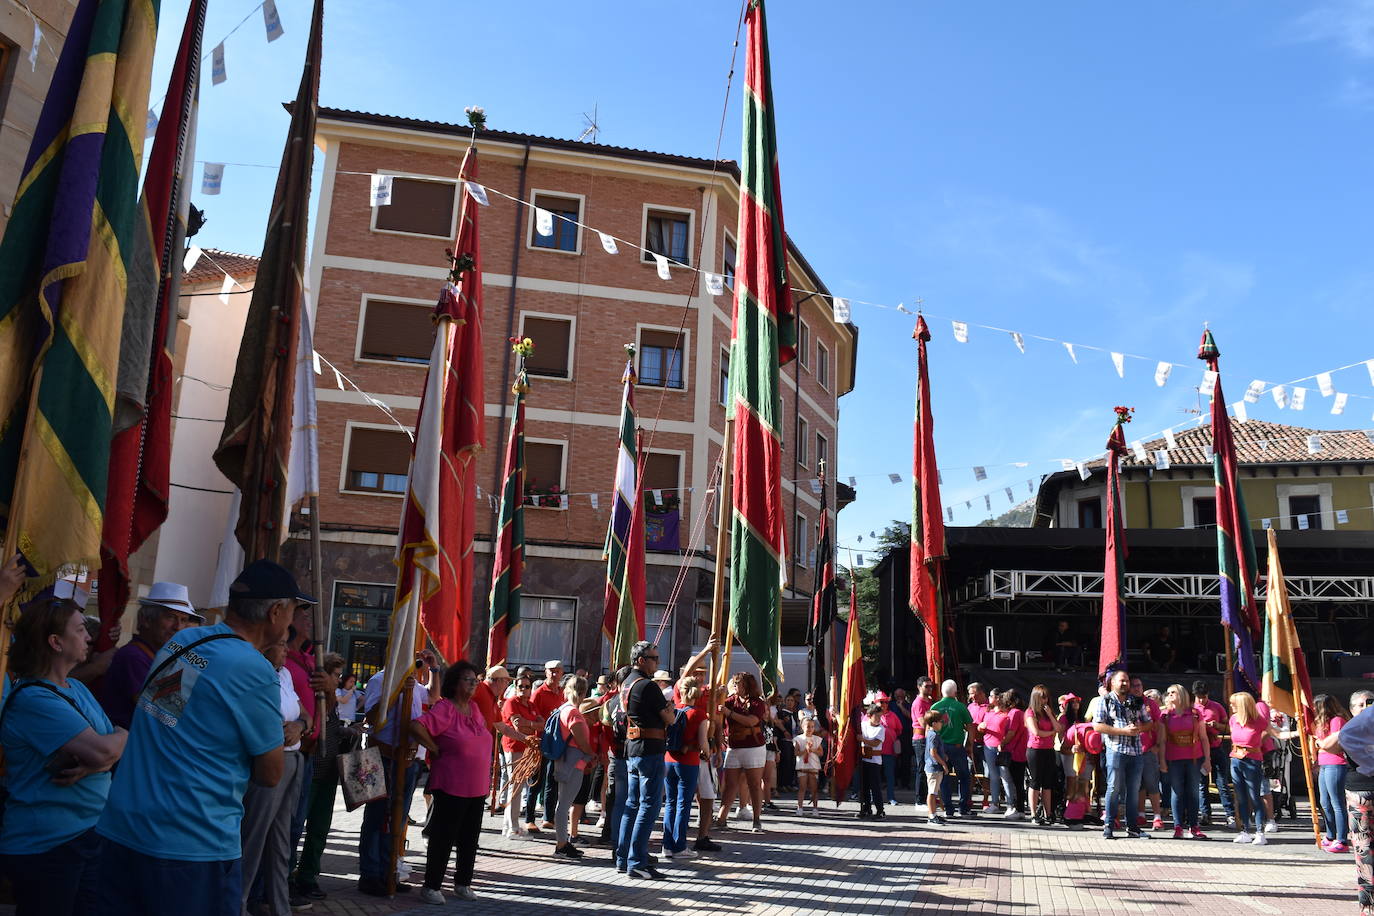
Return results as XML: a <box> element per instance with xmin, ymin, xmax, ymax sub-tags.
<box><xmin>96</xmin><ymin>560</ymin><xmax>315</xmax><ymax>916</ymax></box>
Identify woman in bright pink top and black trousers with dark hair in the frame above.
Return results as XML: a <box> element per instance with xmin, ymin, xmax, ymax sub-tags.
<box><xmin>411</xmin><ymin>662</ymin><xmax>492</xmax><ymax>904</ymax></box>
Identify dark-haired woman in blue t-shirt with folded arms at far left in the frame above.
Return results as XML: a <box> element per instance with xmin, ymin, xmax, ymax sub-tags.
<box><xmin>0</xmin><ymin>597</ymin><xmax>129</xmax><ymax>916</ymax></box>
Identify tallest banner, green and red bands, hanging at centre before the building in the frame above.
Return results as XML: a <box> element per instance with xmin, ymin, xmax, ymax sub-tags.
<box><xmin>728</xmin><ymin>0</ymin><xmax>797</xmax><ymax>694</ymax></box>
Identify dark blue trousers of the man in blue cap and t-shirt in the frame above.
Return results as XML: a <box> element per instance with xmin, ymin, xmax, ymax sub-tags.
<box><xmin>98</xmin><ymin>839</ymin><xmax>243</xmax><ymax>916</ymax></box>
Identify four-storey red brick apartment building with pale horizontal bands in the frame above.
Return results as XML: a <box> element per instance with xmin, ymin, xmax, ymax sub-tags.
<box><xmin>287</xmin><ymin>110</ymin><xmax>857</xmax><ymax>674</ymax></box>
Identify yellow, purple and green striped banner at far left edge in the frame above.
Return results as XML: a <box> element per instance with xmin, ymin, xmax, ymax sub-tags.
<box><xmin>0</xmin><ymin>0</ymin><xmax>159</xmax><ymax>591</ymax></box>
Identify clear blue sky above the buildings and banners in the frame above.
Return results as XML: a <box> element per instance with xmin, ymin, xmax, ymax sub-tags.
<box><xmin>154</xmin><ymin>0</ymin><xmax>1374</xmax><ymax>565</ymax></box>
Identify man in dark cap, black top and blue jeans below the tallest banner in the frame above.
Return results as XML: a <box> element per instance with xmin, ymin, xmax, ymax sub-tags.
<box><xmin>616</xmin><ymin>641</ymin><xmax>676</xmax><ymax>880</ymax></box>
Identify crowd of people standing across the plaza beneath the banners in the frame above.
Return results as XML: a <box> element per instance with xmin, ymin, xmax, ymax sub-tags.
<box><xmin>0</xmin><ymin>560</ymin><xmax>1374</xmax><ymax>916</ymax></box>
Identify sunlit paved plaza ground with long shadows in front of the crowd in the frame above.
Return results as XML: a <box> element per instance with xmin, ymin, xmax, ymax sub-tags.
<box><xmin>303</xmin><ymin>795</ymin><xmax>1356</xmax><ymax>916</ymax></box>
